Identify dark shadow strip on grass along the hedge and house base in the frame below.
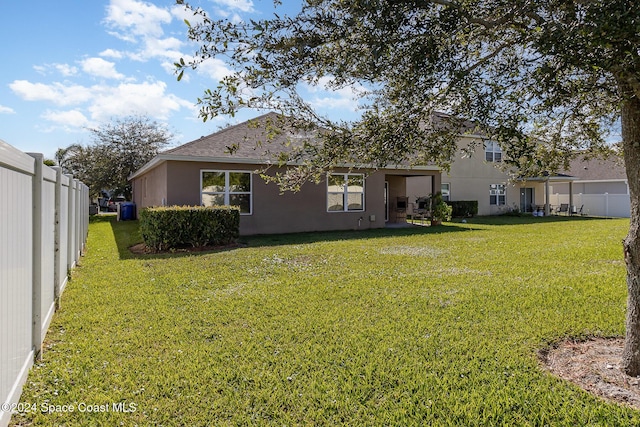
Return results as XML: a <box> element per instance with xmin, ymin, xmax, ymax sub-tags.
<box><xmin>101</xmin><ymin>215</ymin><xmax>474</xmax><ymax>259</ymax></box>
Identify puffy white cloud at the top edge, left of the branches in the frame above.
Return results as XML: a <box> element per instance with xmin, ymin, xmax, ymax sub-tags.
<box><xmin>105</xmin><ymin>0</ymin><xmax>172</xmax><ymax>41</ymax></box>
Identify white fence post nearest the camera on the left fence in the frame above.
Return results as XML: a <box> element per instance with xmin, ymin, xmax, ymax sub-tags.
<box><xmin>27</xmin><ymin>153</ymin><xmax>44</xmax><ymax>360</ymax></box>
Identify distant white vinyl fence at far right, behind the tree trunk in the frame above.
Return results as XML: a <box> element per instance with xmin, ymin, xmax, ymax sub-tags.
<box><xmin>549</xmin><ymin>193</ymin><xmax>631</xmax><ymax>218</ymax></box>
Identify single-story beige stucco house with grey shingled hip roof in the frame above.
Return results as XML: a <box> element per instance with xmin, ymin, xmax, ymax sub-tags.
<box><xmin>130</xmin><ymin>113</ymin><xmax>441</xmax><ymax>235</ymax></box>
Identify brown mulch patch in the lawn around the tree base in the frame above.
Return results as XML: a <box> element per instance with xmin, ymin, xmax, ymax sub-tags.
<box><xmin>540</xmin><ymin>338</ymin><xmax>640</xmax><ymax>409</ymax></box>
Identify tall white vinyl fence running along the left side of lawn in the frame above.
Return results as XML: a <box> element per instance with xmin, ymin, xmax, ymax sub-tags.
<box><xmin>0</xmin><ymin>140</ymin><xmax>89</xmax><ymax>427</ymax></box>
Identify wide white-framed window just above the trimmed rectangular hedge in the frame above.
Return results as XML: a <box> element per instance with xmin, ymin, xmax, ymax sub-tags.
<box><xmin>200</xmin><ymin>170</ymin><xmax>252</xmax><ymax>215</ymax></box>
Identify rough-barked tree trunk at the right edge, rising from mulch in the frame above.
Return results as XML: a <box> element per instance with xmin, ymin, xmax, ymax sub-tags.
<box><xmin>622</xmin><ymin>95</ymin><xmax>640</xmax><ymax>377</ymax></box>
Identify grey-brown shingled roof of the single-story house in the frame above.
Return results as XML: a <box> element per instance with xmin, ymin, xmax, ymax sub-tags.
<box><xmin>129</xmin><ymin>113</ymin><xmax>439</xmax><ymax>179</ymax></box>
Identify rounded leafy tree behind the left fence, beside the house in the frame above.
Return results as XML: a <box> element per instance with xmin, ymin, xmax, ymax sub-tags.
<box><xmin>61</xmin><ymin>116</ymin><xmax>173</xmax><ymax>199</ymax></box>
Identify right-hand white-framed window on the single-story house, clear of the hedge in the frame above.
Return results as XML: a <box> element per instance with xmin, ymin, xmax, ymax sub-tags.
<box><xmin>327</xmin><ymin>173</ymin><xmax>364</xmax><ymax>212</ymax></box>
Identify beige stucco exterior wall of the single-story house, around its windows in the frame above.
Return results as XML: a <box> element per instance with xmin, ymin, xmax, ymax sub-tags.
<box><xmin>134</xmin><ymin>161</ymin><xmax>439</xmax><ymax>235</ymax></box>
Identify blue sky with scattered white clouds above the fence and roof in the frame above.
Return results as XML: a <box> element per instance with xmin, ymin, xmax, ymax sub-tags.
<box><xmin>0</xmin><ymin>0</ymin><xmax>357</xmax><ymax>158</ymax></box>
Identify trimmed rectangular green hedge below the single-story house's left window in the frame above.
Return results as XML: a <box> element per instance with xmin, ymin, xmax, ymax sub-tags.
<box><xmin>140</xmin><ymin>206</ymin><xmax>240</xmax><ymax>250</ymax></box>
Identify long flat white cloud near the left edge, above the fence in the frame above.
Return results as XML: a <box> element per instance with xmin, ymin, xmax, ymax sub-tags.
<box><xmin>9</xmin><ymin>80</ymin><xmax>93</xmax><ymax>106</ymax></box>
